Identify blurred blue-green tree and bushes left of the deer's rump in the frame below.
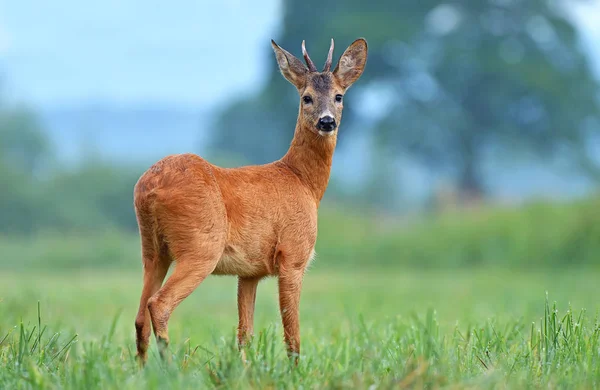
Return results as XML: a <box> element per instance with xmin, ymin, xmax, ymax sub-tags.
<box><xmin>0</xmin><ymin>83</ymin><xmax>139</xmax><ymax>234</ymax></box>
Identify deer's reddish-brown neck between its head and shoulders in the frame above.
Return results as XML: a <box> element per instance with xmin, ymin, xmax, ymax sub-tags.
<box><xmin>281</xmin><ymin>120</ymin><xmax>337</xmax><ymax>206</ymax></box>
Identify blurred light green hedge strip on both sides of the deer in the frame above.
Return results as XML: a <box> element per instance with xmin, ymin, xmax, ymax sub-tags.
<box><xmin>0</xmin><ymin>198</ymin><xmax>600</xmax><ymax>270</ymax></box>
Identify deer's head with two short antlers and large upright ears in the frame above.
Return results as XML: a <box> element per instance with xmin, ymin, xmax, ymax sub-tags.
<box><xmin>271</xmin><ymin>38</ymin><xmax>367</xmax><ymax>137</ymax></box>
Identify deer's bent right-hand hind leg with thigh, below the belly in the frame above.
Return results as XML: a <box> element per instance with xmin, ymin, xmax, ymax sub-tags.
<box><xmin>148</xmin><ymin>234</ymin><xmax>224</xmax><ymax>359</ymax></box>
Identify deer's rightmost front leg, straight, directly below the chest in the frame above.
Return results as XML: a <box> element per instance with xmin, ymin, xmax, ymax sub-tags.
<box><xmin>279</xmin><ymin>267</ymin><xmax>304</xmax><ymax>364</ymax></box>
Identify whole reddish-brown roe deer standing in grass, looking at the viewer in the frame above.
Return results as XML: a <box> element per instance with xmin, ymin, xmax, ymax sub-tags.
<box><xmin>133</xmin><ymin>38</ymin><xmax>367</xmax><ymax>366</ymax></box>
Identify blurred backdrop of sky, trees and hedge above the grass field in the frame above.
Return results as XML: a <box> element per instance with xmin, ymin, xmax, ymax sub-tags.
<box><xmin>0</xmin><ymin>0</ymin><xmax>600</xmax><ymax>270</ymax></box>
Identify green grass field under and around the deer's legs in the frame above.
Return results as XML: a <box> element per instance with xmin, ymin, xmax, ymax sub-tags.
<box><xmin>0</xmin><ymin>265</ymin><xmax>600</xmax><ymax>389</ymax></box>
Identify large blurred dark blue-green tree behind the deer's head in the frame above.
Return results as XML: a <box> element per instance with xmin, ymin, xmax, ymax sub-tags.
<box><xmin>212</xmin><ymin>0</ymin><xmax>598</xmax><ymax>201</ymax></box>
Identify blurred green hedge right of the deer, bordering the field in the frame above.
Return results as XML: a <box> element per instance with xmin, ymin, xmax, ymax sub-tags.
<box><xmin>317</xmin><ymin>199</ymin><xmax>600</xmax><ymax>268</ymax></box>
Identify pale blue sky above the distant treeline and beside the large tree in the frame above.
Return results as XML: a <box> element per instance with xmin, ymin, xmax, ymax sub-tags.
<box><xmin>0</xmin><ymin>0</ymin><xmax>600</xmax><ymax>109</ymax></box>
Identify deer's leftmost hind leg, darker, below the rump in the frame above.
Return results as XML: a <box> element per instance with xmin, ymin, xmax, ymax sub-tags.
<box><xmin>135</xmin><ymin>225</ymin><xmax>171</xmax><ymax>365</ymax></box>
